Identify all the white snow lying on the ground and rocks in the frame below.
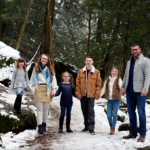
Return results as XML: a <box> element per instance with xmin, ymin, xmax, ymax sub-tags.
<box><xmin>0</xmin><ymin>42</ymin><xmax>150</xmax><ymax>150</ymax></box>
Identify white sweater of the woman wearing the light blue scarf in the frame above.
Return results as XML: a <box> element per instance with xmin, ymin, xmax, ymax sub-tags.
<box><xmin>30</xmin><ymin>69</ymin><xmax>57</xmax><ymax>93</ymax></box>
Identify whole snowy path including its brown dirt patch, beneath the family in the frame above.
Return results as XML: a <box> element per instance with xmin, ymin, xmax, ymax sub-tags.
<box><xmin>0</xmin><ymin>95</ymin><xmax>150</xmax><ymax>150</ymax></box>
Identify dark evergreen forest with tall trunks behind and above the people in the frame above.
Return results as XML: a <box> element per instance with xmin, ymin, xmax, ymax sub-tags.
<box><xmin>0</xmin><ymin>0</ymin><xmax>150</xmax><ymax>92</ymax></box>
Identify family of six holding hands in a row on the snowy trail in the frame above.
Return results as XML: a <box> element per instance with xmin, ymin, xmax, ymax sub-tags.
<box><xmin>10</xmin><ymin>44</ymin><xmax>150</xmax><ymax>142</ymax></box>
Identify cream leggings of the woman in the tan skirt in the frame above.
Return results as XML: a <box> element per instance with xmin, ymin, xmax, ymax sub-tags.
<box><xmin>36</xmin><ymin>102</ymin><xmax>50</xmax><ymax>125</ymax></box>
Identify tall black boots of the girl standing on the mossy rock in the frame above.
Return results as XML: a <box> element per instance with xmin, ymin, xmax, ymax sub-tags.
<box><xmin>14</xmin><ymin>94</ymin><xmax>22</xmax><ymax>114</ymax></box>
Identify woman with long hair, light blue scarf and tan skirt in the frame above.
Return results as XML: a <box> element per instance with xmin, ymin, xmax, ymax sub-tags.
<box><xmin>30</xmin><ymin>54</ymin><xmax>57</xmax><ymax>134</ymax></box>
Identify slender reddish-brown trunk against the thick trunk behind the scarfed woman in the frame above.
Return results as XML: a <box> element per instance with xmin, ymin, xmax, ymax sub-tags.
<box><xmin>48</xmin><ymin>0</ymin><xmax>55</xmax><ymax>71</ymax></box>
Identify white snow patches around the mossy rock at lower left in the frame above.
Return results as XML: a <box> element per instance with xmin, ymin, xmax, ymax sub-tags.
<box><xmin>0</xmin><ymin>84</ymin><xmax>37</xmax><ymax>150</ymax></box>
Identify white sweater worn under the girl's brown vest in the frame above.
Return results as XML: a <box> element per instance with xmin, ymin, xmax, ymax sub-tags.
<box><xmin>100</xmin><ymin>76</ymin><xmax>122</xmax><ymax>100</ymax></box>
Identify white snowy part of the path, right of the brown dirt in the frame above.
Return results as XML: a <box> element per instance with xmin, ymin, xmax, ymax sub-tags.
<box><xmin>47</xmin><ymin>98</ymin><xmax>150</xmax><ymax>150</ymax></box>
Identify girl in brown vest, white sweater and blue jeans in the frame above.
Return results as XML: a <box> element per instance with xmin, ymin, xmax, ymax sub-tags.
<box><xmin>100</xmin><ymin>66</ymin><xmax>122</xmax><ymax>135</ymax></box>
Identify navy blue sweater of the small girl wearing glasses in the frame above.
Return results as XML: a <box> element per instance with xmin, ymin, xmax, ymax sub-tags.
<box><xmin>55</xmin><ymin>82</ymin><xmax>76</xmax><ymax>106</ymax></box>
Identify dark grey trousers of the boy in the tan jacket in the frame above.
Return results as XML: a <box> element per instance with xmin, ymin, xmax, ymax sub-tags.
<box><xmin>80</xmin><ymin>96</ymin><xmax>95</xmax><ymax>130</ymax></box>
